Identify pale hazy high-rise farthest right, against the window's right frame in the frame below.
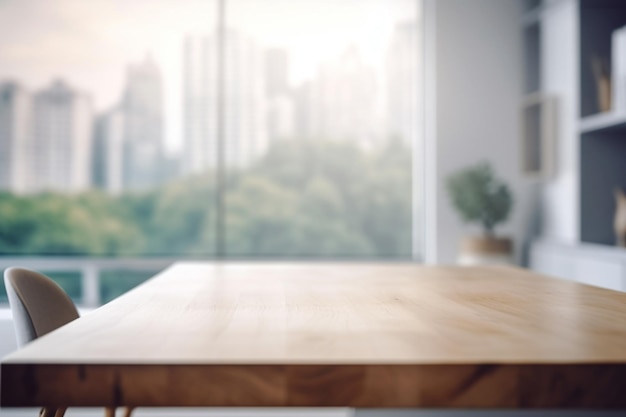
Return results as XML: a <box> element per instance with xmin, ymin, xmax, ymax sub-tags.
<box><xmin>386</xmin><ymin>21</ymin><xmax>421</xmax><ymax>146</ymax></box>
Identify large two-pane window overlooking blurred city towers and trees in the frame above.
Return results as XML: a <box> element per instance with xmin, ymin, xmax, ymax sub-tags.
<box><xmin>0</xmin><ymin>0</ymin><xmax>422</xmax><ymax>300</ymax></box>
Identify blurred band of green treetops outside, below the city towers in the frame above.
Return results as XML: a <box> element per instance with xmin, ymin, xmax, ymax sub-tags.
<box><xmin>0</xmin><ymin>140</ymin><xmax>412</xmax><ymax>257</ymax></box>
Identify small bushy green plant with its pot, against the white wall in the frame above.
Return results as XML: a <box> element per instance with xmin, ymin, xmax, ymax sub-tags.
<box><xmin>446</xmin><ymin>162</ymin><xmax>513</xmax><ymax>265</ymax></box>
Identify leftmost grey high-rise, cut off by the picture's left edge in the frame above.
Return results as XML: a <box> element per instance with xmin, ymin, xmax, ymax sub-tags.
<box><xmin>0</xmin><ymin>81</ymin><xmax>31</xmax><ymax>193</ymax></box>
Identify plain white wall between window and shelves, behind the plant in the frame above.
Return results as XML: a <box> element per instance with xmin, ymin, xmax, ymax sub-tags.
<box><xmin>426</xmin><ymin>0</ymin><xmax>531</xmax><ymax>263</ymax></box>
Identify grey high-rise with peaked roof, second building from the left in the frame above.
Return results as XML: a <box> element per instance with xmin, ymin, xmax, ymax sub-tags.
<box><xmin>24</xmin><ymin>80</ymin><xmax>93</xmax><ymax>192</ymax></box>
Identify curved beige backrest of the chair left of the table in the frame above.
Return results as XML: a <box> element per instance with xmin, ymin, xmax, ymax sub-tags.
<box><xmin>4</xmin><ymin>267</ymin><xmax>78</xmax><ymax>347</ymax></box>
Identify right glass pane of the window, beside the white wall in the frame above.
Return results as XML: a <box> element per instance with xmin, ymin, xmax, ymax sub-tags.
<box><xmin>223</xmin><ymin>0</ymin><xmax>421</xmax><ymax>258</ymax></box>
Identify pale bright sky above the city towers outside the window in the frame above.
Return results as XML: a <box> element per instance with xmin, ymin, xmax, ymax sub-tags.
<box><xmin>0</xmin><ymin>0</ymin><xmax>419</xmax><ymax>152</ymax></box>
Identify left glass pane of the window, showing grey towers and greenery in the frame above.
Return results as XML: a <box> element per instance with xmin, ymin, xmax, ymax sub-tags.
<box><xmin>0</xmin><ymin>0</ymin><xmax>217</xmax><ymax>256</ymax></box>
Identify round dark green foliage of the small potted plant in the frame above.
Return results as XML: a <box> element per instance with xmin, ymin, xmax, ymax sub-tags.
<box><xmin>446</xmin><ymin>162</ymin><xmax>513</xmax><ymax>236</ymax></box>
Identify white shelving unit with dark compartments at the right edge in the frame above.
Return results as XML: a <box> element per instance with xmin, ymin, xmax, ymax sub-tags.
<box><xmin>522</xmin><ymin>0</ymin><xmax>626</xmax><ymax>291</ymax></box>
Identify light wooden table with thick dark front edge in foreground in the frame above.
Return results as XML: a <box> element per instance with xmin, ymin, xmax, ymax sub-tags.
<box><xmin>1</xmin><ymin>262</ymin><xmax>626</xmax><ymax>408</ymax></box>
